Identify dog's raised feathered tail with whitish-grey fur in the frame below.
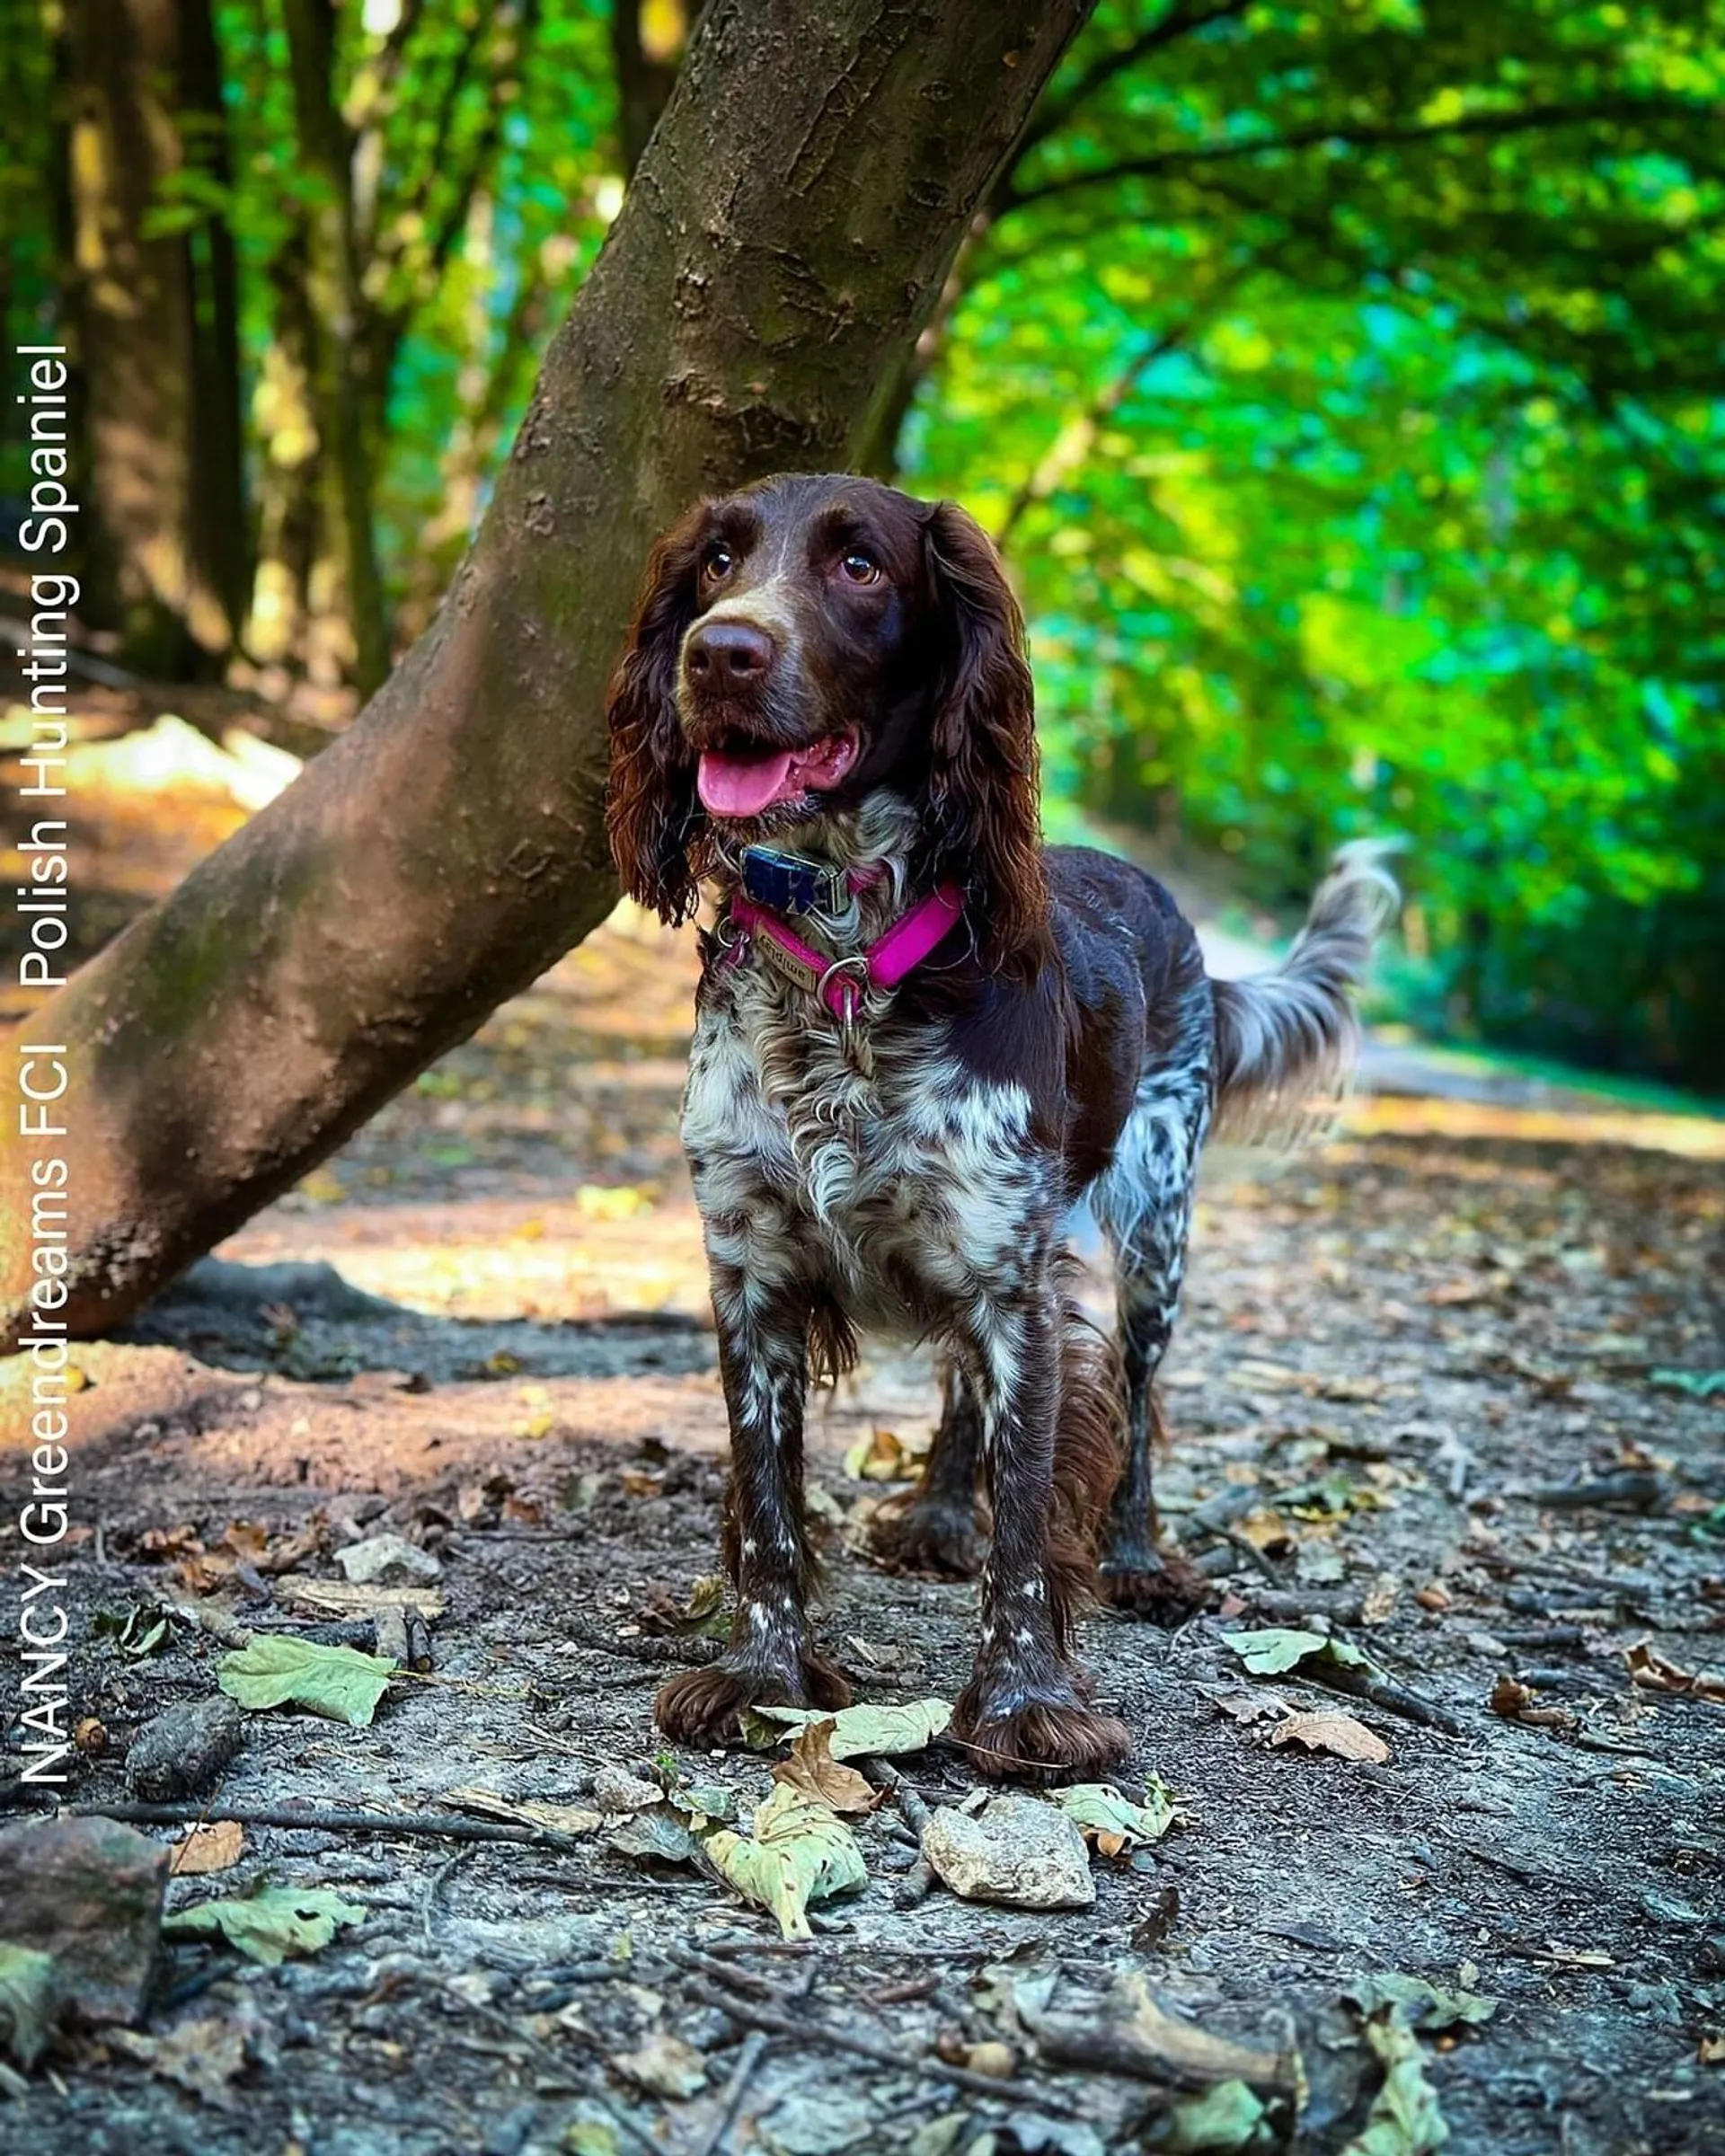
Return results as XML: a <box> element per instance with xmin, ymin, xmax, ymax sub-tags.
<box><xmin>1212</xmin><ymin>839</ymin><xmax>1402</xmax><ymax>1143</ymax></box>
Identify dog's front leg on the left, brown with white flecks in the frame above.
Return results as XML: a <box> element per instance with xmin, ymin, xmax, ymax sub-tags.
<box><xmin>656</xmin><ymin>1257</ymin><xmax>850</xmax><ymax>1745</ymax></box>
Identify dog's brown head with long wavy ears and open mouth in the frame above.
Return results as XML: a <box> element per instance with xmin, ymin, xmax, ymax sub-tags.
<box><xmin>608</xmin><ymin>476</ymin><xmax>1048</xmax><ymax>968</ymax></box>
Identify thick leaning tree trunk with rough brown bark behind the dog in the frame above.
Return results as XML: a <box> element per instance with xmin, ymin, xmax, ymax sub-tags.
<box><xmin>0</xmin><ymin>0</ymin><xmax>1089</xmax><ymax>1332</ymax></box>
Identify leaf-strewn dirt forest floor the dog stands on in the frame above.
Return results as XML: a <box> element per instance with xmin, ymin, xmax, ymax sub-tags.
<box><xmin>0</xmin><ymin>711</ymin><xmax>1725</xmax><ymax>2156</ymax></box>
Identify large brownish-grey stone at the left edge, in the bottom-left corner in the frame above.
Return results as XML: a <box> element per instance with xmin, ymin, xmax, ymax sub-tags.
<box><xmin>0</xmin><ymin>1820</ymin><xmax>168</xmax><ymax>2022</ymax></box>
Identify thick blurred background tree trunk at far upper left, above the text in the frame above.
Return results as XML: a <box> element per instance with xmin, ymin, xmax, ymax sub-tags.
<box><xmin>60</xmin><ymin>0</ymin><xmax>246</xmax><ymax>679</ymax></box>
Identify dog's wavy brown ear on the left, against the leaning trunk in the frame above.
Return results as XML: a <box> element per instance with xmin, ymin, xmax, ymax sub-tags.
<box><xmin>606</xmin><ymin>505</ymin><xmax>705</xmax><ymax>927</ymax></box>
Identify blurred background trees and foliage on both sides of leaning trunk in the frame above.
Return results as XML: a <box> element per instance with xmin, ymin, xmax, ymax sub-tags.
<box><xmin>0</xmin><ymin>0</ymin><xmax>1725</xmax><ymax>1089</ymax></box>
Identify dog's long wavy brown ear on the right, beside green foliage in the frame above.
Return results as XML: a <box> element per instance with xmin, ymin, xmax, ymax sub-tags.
<box><xmin>923</xmin><ymin>502</ymin><xmax>1050</xmax><ymax>979</ymax></box>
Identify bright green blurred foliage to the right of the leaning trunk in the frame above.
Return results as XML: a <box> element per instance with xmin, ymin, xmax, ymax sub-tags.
<box><xmin>906</xmin><ymin>0</ymin><xmax>1725</xmax><ymax>1084</ymax></box>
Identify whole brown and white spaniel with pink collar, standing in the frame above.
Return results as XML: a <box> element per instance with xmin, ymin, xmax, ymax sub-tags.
<box><xmin>610</xmin><ymin>476</ymin><xmax>1395</xmax><ymax>1779</ymax></box>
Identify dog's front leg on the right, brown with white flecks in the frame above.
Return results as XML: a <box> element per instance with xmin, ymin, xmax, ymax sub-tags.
<box><xmin>953</xmin><ymin>1259</ymin><xmax>1130</xmax><ymax>1780</ymax></box>
